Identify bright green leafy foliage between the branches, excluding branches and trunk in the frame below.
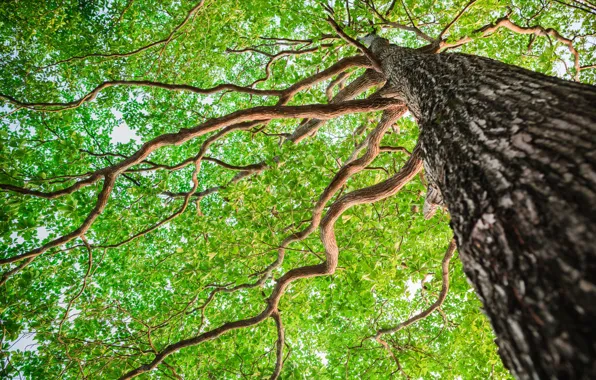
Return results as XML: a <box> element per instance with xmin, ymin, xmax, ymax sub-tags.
<box><xmin>0</xmin><ymin>0</ymin><xmax>596</xmax><ymax>379</ymax></box>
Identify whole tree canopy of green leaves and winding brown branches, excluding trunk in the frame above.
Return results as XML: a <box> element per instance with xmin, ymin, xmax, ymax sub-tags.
<box><xmin>0</xmin><ymin>0</ymin><xmax>596</xmax><ymax>379</ymax></box>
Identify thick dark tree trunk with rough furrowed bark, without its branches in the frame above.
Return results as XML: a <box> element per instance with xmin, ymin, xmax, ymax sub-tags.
<box><xmin>371</xmin><ymin>38</ymin><xmax>596</xmax><ymax>379</ymax></box>
